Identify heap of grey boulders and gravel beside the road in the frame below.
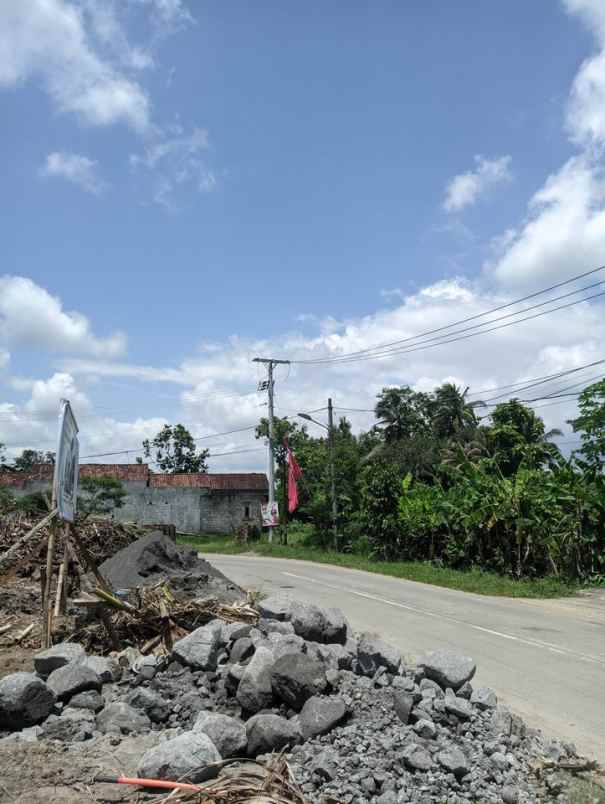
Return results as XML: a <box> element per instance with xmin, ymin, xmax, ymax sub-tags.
<box><xmin>0</xmin><ymin>598</ymin><xmax>575</xmax><ymax>804</ymax></box>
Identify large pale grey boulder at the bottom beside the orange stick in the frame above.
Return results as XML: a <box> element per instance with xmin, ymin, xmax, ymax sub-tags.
<box><xmin>137</xmin><ymin>731</ymin><xmax>221</xmax><ymax>783</ymax></box>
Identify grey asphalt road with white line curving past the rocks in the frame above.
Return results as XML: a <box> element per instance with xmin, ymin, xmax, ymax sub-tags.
<box><xmin>207</xmin><ymin>555</ymin><xmax>605</xmax><ymax>764</ymax></box>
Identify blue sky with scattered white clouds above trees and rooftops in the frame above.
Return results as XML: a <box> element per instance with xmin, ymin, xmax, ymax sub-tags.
<box><xmin>0</xmin><ymin>0</ymin><xmax>605</xmax><ymax>471</ymax></box>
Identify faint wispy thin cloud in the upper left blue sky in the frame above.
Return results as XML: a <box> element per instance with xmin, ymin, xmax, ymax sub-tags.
<box><xmin>130</xmin><ymin>126</ymin><xmax>217</xmax><ymax>209</ymax></box>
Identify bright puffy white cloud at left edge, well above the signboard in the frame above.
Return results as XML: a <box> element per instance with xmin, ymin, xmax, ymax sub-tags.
<box><xmin>0</xmin><ymin>275</ymin><xmax>125</xmax><ymax>356</ymax></box>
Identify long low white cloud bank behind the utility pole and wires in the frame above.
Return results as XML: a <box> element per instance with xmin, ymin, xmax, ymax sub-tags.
<box><xmin>0</xmin><ymin>280</ymin><xmax>605</xmax><ymax>472</ymax></box>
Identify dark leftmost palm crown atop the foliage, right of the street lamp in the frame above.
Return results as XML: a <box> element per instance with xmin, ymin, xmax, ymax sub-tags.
<box><xmin>374</xmin><ymin>386</ymin><xmax>431</xmax><ymax>443</ymax></box>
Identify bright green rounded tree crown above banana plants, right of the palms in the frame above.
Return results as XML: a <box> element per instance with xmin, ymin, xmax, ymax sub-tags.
<box><xmin>487</xmin><ymin>399</ymin><xmax>561</xmax><ymax>477</ymax></box>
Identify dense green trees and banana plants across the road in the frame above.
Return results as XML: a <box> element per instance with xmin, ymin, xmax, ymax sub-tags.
<box><xmin>257</xmin><ymin>381</ymin><xmax>605</xmax><ymax>580</ymax></box>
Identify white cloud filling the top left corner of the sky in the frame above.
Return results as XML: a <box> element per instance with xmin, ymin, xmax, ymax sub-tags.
<box><xmin>0</xmin><ymin>0</ymin><xmax>150</xmax><ymax>131</ymax></box>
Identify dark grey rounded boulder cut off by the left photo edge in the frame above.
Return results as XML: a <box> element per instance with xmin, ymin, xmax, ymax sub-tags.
<box><xmin>0</xmin><ymin>673</ymin><xmax>55</xmax><ymax>730</ymax></box>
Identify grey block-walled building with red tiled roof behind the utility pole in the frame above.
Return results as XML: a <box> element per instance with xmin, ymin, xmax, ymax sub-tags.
<box><xmin>0</xmin><ymin>463</ymin><xmax>269</xmax><ymax>533</ymax></box>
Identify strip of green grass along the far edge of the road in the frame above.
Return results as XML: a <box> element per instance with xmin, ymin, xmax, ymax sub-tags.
<box><xmin>178</xmin><ymin>534</ymin><xmax>580</xmax><ymax>598</ymax></box>
